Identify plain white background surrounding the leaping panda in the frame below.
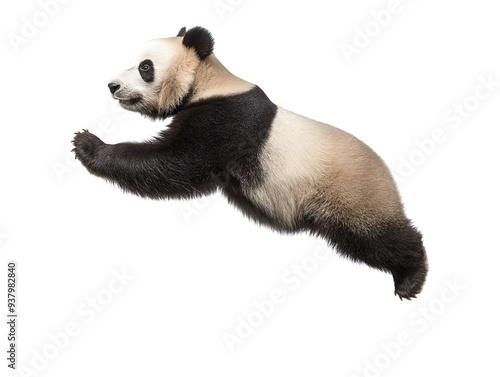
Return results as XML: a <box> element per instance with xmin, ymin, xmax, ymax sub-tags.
<box><xmin>0</xmin><ymin>0</ymin><xmax>500</xmax><ymax>377</ymax></box>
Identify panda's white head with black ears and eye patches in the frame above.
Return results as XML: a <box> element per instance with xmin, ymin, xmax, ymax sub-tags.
<box><xmin>108</xmin><ymin>27</ymin><xmax>214</xmax><ymax>119</ymax></box>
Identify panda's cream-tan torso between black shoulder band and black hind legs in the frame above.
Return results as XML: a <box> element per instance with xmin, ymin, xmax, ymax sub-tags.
<box><xmin>243</xmin><ymin>107</ymin><xmax>400</xmax><ymax>230</ymax></box>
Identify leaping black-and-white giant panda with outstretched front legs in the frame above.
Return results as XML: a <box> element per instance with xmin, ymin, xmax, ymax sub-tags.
<box><xmin>73</xmin><ymin>27</ymin><xmax>428</xmax><ymax>299</ymax></box>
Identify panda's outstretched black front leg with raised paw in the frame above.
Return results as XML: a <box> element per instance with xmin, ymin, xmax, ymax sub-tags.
<box><xmin>73</xmin><ymin>130</ymin><xmax>210</xmax><ymax>199</ymax></box>
